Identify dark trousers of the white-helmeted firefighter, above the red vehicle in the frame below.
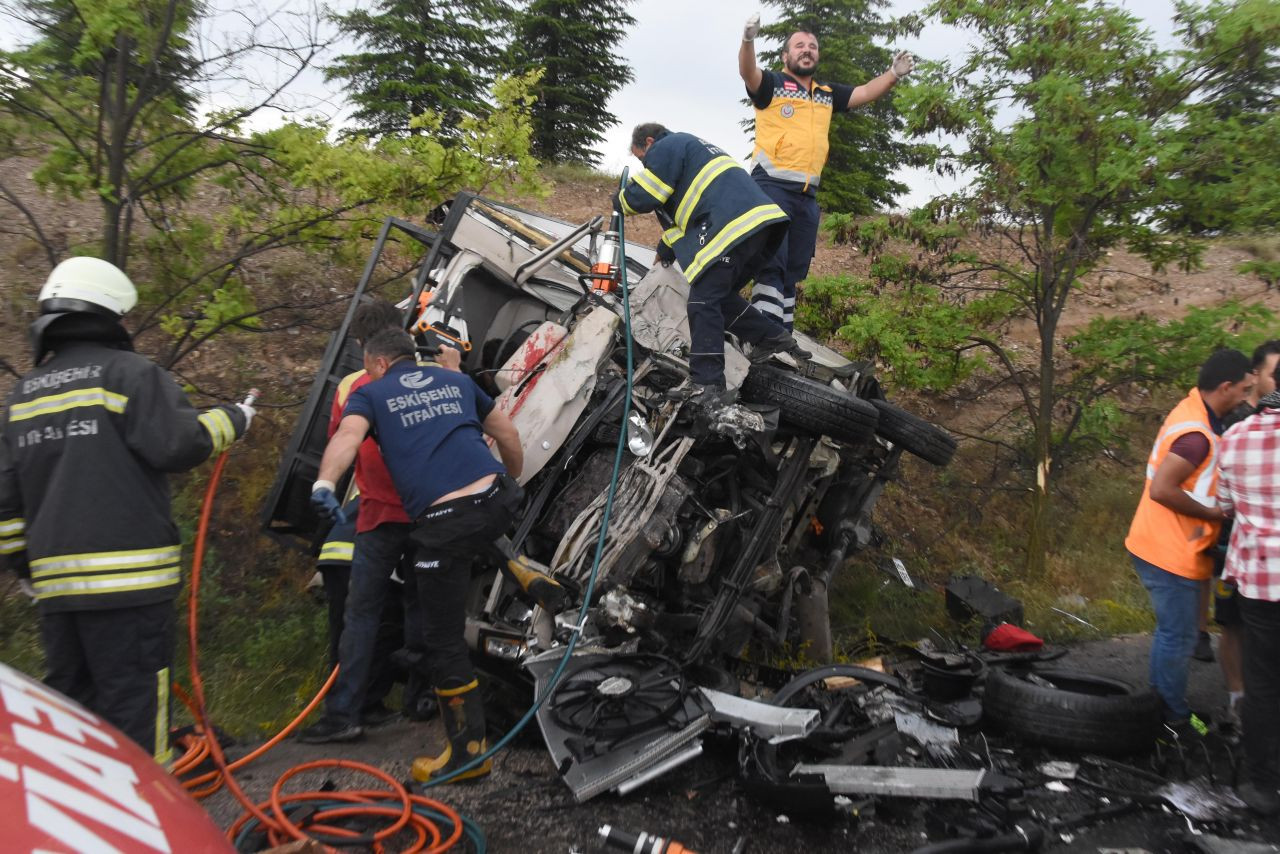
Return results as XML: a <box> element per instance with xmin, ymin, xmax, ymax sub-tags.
<box><xmin>40</xmin><ymin>602</ymin><xmax>174</xmax><ymax>762</ymax></box>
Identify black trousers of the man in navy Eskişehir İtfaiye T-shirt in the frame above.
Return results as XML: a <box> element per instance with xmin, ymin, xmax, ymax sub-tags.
<box><xmin>412</xmin><ymin>475</ymin><xmax>522</xmax><ymax>690</ymax></box>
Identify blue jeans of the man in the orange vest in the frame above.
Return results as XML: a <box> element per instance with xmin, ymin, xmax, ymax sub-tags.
<box><xmin>1130</xmin><ymin>554</ymin><xmax>1203</xmax><ymax>721</ymax></box>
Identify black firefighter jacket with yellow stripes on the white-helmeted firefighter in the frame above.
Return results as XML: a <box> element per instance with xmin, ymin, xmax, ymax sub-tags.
<box><xmin>0</xmin><ymin>342</ymin><xmax>244</xmax><ymax>612</ymax></box>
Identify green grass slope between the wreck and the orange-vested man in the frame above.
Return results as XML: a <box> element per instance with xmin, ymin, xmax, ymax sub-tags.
<box><xmin>832</xmin><ymin>423</ymin><xmax>1153</xmax><ymax>648</ymax></box>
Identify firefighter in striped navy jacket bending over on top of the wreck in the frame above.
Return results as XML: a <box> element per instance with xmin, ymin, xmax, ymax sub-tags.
<box><xmin>617</xmin><ymin>123</ymin><xmax>810</xmax><ymax>408</ymax></box>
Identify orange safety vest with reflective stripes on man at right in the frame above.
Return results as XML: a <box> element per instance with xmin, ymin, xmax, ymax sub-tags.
<box><xmin>1124</xmin><ymin>389</ymin><xmax>1220</xmax><ymax>579</ymax></box>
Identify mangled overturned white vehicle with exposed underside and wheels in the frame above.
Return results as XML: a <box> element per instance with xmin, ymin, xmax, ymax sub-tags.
<box><xmin>264</xmin><ymin>195</ymin><xmax>955</xmax><ymax>798</ymax></box>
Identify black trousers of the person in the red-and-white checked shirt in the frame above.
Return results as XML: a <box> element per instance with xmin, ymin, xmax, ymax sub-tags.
<box><xmin>1238</xmin><ymin>595</ymin><xmax>1280</xmax><ymax>791</ymax></box>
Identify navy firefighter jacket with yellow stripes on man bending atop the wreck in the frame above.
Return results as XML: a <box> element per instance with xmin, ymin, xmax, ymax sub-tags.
<box><xmin>618</xmin><ymin>133</ymin><xmax>787</xmax><ymax>283</ymax></box>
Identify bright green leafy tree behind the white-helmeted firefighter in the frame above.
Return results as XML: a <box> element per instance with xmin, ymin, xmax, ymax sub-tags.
<box><xmin>0</xmin><ymin>0</ymin><xmax>536</xmax><ymax>366</ymax></box>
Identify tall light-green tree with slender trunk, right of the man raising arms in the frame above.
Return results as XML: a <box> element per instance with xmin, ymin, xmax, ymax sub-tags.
<box><xmin>824</xmin><ymin>0</ymin><xmax>1280</xmax><ymax>571</ymax></box>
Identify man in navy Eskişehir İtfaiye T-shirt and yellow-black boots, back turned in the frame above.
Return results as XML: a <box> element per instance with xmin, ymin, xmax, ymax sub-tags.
<box><xmin>311</xmin><ymin>329</ymin><xmax>524</xmax><ymax>782</ymax></box>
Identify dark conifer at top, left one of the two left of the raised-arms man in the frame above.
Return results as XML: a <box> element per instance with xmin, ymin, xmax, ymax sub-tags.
<box><xmin>325</xmin><ymin>0</ymin><xmax>509</xmax><ymax>136</ymax></box>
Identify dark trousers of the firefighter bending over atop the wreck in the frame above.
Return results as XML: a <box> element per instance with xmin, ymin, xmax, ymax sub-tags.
<box><xmin>689</xmin><ymin>229</ymin><xmax>787</xmax><ymax>387</ymax></box>
